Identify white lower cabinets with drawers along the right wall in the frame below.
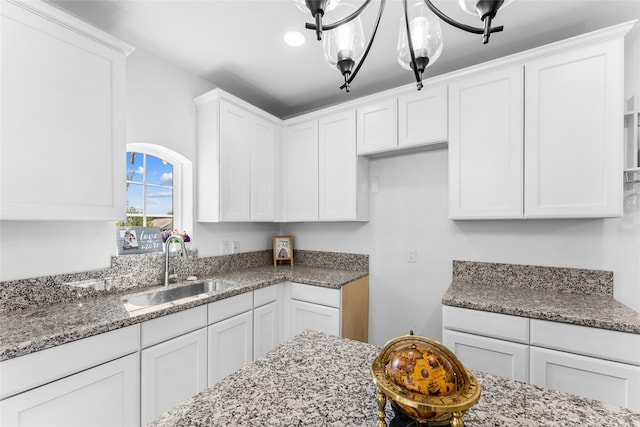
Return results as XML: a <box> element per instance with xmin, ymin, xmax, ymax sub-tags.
<box><xmin>442</xmin><ymin>306</ymin><xmax>640</xmax><ymax>411</ymax></box>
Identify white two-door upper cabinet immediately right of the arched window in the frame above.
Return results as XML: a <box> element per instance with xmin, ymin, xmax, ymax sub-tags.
<box><xmin>194</xmin><ymin>89</ymin><xmax>281</xmax><ymax>222</ymax></box>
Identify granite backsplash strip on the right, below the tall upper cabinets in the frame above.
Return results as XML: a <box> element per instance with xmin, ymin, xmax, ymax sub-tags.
<box><xmin>453</xmin><ymin>260</ymin><xmax>613</xmax><ymax>297</ymax></box>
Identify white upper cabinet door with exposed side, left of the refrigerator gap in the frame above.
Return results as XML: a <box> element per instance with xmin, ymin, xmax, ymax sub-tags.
<box><xmin>318</xmin><ymin>111</ymin><xmax>369</xmax><ymax>221</ymax></box>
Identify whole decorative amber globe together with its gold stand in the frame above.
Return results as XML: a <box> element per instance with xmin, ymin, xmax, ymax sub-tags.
<box><xmin>371</xmin><ymin>335</ymin><xmax>480</xmax><ymax>427</ymax></box>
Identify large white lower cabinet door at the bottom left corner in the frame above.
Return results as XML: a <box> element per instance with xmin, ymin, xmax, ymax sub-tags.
<box><xmin>0</xmin><ymin>353</ymin><xmax>140</xmax><ymax>427</ymax></box>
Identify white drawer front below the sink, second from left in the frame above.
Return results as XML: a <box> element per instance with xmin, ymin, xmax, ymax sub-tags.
<box><xmin>141</xmin><ymin>305</ymin><xmax>207</xmax><ymax>348</ymax></box>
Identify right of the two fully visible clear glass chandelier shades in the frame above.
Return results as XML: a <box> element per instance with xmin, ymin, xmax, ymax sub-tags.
<box><xmin>397</xmin><ymin>0</ymin><xmax>443</xmax><ymax>73</ymax></box>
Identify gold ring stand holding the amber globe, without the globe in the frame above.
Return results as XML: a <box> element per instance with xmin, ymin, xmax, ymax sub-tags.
<box><xmin>371</xmin><ymin>335</ymin><xmax>480</xmax><ymax>427</ymax></box>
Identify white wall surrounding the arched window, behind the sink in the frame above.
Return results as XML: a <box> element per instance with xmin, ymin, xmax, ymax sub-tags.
<box><xmin>0</xmin><ymin>49</ymin><xmax>278</xmax><ymax>281</ymax></box>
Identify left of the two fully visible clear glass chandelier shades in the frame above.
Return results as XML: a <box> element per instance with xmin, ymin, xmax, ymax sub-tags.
<box><xmin>322</xmin><ymin>3</ymin><xmax>366</xmax><ymax>70</ymax></box>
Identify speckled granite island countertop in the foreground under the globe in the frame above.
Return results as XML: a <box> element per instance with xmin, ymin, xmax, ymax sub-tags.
<box><xmin>149</xmin><ymin>331</ymin><xmax>640</xmax><ymax>427</ymax></box>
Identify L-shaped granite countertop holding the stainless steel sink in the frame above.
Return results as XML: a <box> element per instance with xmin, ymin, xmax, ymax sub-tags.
<box><xmin>0</xmin><ymin>265</ymin><xmax>368</xmax><ymax>361</ymax></box>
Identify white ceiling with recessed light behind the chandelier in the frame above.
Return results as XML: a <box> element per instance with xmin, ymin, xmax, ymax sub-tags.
<box><xmin>51</xmin><ymin>0</ymin><xmax>640</xmax><ymax>118</ymax></box>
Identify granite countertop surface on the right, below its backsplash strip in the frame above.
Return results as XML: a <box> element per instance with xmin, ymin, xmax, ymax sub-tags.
<box><xmin>442</xmin><ymin>280</ymin><xmax>640</xmax><ymax>334</ymax></box>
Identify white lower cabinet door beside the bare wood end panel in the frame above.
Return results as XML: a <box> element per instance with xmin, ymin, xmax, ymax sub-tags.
<box><xmin>289</xmin><ymin>300</ymin><xmax>340</xmax><ymax>336</ymax></box>
